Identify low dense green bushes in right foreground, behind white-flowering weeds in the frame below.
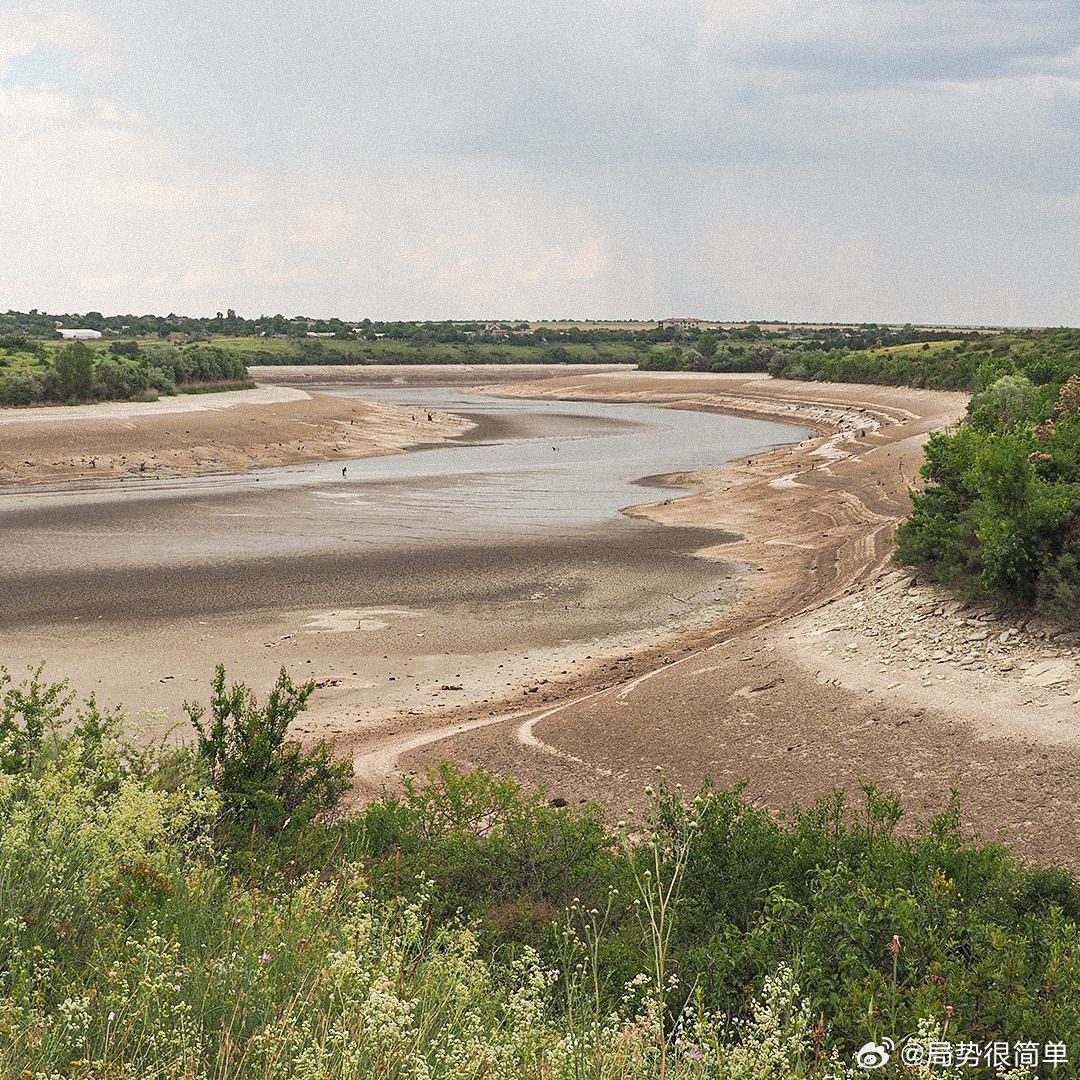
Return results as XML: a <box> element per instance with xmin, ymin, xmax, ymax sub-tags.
<box><xmin>346</xmin><ymin>767</ymin><xmax>1080</xmax><ymax>1048</ymax></box>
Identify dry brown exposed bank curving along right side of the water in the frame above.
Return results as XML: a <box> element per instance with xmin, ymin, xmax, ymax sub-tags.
<box><xmin>343</xmin><ymin>374</ymin><xmax>1080</xmax><ymax>865</ymax></box>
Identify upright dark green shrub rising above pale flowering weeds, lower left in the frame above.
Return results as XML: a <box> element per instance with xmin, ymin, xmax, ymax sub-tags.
<box><xmin>184</xmin><ymin>664</ymin><xmax>352</xmax><ymax>834</ymax></box>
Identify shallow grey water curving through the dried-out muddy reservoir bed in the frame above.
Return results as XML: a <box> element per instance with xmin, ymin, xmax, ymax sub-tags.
<box><xmin>0</xmin><ymin>387</ymin><xmax>809</xmax><ymax>583</ymax></box>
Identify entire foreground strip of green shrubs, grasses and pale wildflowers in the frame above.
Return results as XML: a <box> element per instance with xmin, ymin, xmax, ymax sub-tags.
<box><xmin>0</xmin><ymin>670</ymin><xmax>1080</xmax><ymax>1080</ymax></box>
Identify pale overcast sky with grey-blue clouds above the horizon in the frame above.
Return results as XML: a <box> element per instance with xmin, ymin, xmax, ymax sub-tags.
<box><xmin>0</xmin><ymin>0</ymin><xmax>1080</xmax><ymax>326</ymax></box>
